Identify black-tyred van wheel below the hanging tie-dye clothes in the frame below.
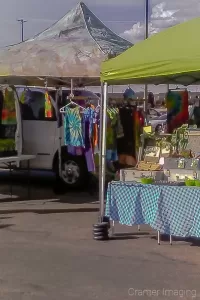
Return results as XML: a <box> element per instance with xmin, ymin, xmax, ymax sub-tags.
<box><xmin>57</xmin><ymin>154</ymin><xmax>89</xmax><ymax>188</ymax></box>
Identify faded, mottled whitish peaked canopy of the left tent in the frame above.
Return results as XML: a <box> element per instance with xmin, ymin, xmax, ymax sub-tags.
<box><xmin>0</xmin><ymin>2</ymin><xmax>132</xmax><ymax>85</ymax></box>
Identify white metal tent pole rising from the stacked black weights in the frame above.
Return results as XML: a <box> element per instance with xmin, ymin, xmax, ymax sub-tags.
<box><xmin>99</xmin><ymin>82</ymin><xmax>108</xmax><ymax>220</ymax></box>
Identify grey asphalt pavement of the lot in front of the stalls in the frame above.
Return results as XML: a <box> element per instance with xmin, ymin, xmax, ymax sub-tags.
<box><xmin>0</xmin><ymin>170</ymin><xmax>200</xmax><ymax>300</ymax></box>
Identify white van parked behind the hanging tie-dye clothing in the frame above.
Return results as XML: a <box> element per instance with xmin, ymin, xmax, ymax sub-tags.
<box><xmin>4</xmin><ymin>87</ymin><xmax>99</xmax><ymax>187</ymax></box>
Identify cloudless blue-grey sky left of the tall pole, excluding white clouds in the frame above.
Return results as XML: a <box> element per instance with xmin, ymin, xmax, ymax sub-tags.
<box><xmin>0</xmin><ymin>0</ymin><xmax>144</xmax><ymax>46</ymax></box>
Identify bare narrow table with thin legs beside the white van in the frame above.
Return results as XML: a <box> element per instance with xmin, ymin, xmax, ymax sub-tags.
<box><xmin>0</xmin><ymin>154</ymin><xmax>36</xmax><ymax>199</ymax></box>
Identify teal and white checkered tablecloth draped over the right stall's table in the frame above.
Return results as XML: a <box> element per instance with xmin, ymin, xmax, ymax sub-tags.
<box><xmin>106</xmin><ymin>181</ymin><xmax>200</xmax><ymax>237</ymax></box>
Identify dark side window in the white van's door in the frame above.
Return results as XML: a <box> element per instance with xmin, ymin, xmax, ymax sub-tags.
<box><xmin>21</xmin><ymin>91</ymin><xmax>56</xmax><ymax>121</ymax></box>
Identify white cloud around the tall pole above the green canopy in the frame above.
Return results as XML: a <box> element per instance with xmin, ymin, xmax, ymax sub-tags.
<box><xmin>122</xmin><ymin>0</ymin><xmax>200</xmax><ymax>43</ymax></box>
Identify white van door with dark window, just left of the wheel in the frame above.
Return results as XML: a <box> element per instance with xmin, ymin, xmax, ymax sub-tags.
<box><xmin>20</xmin><ymin>91</ymin><xmax>57</xmax><ymax>170</ymax></box>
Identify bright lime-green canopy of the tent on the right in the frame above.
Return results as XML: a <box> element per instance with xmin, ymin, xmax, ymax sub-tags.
<box><xmin>101</xmin><ymin>18</ymin><xmax>200</xmax><ymax>85</ymax></box>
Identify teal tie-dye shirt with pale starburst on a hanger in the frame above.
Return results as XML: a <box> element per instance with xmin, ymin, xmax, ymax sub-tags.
<box><xmin>64</xmin><ymin>107</ymin><xmax>85</xmax><ymax>147</ymax></box>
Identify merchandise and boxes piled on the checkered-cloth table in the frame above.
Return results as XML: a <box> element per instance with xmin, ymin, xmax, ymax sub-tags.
<box><xmin>120</xmin><ymin>125</ymin><xmax>200</xmax><ymax>186</ymax></box>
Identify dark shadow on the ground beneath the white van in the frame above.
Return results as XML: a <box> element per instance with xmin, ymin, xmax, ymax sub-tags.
<box><xmin>0</xmin><ymin>170</ymin><xmax>97</xmax><ymax>204</ymax></box>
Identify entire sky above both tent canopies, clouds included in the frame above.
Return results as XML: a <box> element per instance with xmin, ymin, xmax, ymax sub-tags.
<box><xmin>0</xmin><ymin>0</ymin><xmax>200</xmax><ymax>46</ymax></box>
